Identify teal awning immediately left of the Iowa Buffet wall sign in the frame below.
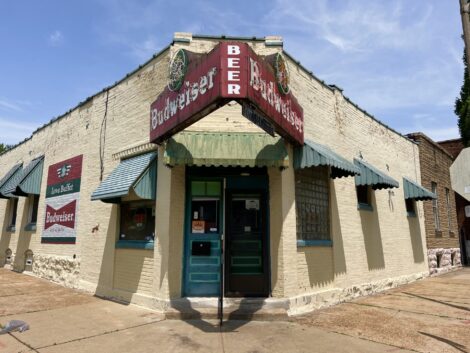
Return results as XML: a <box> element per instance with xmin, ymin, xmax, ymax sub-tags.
<box><xmin>2</xmin><ymin>156</ymin><xmax>44</xmax><ymax>196</ymax></box>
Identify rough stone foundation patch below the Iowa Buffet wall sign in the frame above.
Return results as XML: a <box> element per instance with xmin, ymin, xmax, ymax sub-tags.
<box><xmin>32</xmin><ymin>255</ymin><xmax>80</xmax><ymax>288</ymax></box>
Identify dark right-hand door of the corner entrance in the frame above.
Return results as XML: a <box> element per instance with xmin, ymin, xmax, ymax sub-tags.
<box><xmin>225</xmin><ymin>190</ymin><xmax>269</xmax><ymax>297</ymax></box>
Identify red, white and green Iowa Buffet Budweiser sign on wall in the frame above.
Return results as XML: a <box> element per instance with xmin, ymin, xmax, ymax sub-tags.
<box><xmin>41</xmin><ymin>155</ymin><xmax>83</xmax><ymax>244</ymax></box>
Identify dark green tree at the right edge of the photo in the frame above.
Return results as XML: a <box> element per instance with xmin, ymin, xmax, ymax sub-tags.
<box><xmin>454</xmin><ymin>51</ymin><xmax>470</xmax><ymax>147</ymax></box>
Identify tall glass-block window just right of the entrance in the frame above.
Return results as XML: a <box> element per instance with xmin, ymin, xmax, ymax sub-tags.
<box><xmin>295</xmin><ymin>167</ymin><xmax>330</xmax><ymax>240</ymax></box>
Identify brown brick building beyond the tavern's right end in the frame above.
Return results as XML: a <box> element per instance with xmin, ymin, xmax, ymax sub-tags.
<box><xmin>408</xmin><ymin>133</ymin><xmax>461</xmax><ymax>274</ymax></box>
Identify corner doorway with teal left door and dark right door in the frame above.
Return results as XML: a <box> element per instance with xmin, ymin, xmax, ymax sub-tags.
<box><xmin>183</xmin><ymin>167</ymin><xmax>270</xmax><ymax>297</ymax></box>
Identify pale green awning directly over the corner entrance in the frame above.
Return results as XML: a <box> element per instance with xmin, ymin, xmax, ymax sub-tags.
<box><xmin>164</xmin><ymin>132</ymin><xmax>289</xmax><ymax>168</ymax></box>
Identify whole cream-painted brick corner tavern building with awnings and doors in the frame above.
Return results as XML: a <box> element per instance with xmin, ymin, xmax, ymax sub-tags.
<box><xmin>0</xmin><ymin>33</ymin><xmax>432</xmax><ymax>314</ymax></box>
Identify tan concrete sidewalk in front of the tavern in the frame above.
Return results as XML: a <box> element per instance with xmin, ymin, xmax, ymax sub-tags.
<box><xmin>0</xmin><ymin>269</ymin><xmax>470</xmax><ymax>353</ymax></box>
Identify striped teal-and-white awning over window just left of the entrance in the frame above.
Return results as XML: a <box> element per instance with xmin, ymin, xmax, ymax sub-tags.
<box><xmin>91</xmin><ymin>152</ymin><xmax>157</xmax><ymax>203</ymax></box>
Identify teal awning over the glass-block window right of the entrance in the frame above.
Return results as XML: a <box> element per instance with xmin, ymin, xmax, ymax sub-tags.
<box><xmin>294</xmin><ymin>140</ymin><xmax>361</xmax><ymax>179</ymax></box>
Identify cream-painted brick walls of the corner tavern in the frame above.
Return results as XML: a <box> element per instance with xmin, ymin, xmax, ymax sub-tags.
<box><xmin>0</xmin><ymin>39</ymin><xmax>427</xmax><ymax>306</ymax></box>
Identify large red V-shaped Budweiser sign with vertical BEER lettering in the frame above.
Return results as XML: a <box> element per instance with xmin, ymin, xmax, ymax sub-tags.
<box><xmin>150</xmin><ymin>42</ymin><xmax>304</xmax><ymax>144</ymax></box>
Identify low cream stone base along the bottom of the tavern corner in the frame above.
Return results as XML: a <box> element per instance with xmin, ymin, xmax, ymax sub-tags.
<box><xmin>92</xmin><ymin>272</ymin><xmax>429</xmax><ymax>321</ymax></box>
